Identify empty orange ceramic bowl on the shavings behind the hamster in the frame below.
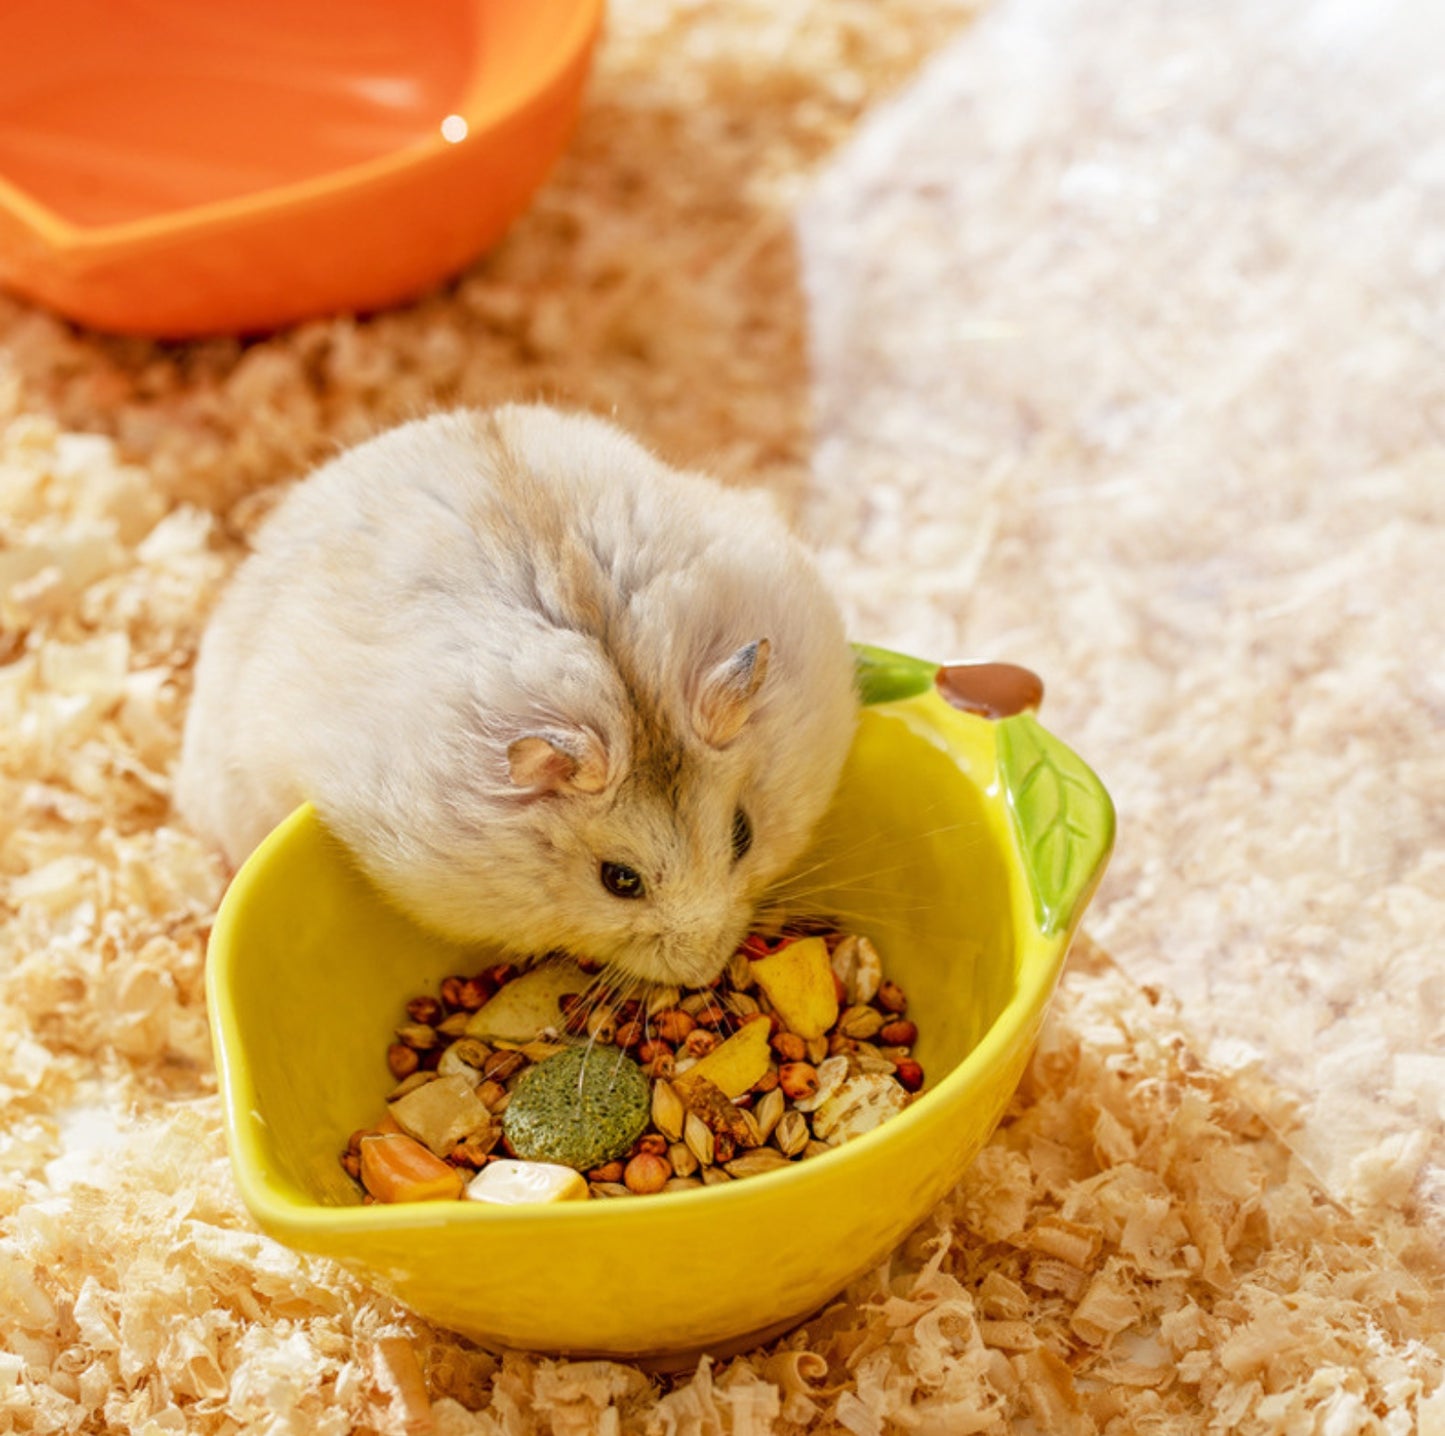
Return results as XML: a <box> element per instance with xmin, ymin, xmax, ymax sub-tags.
<box><xmin>0</xmin><ymin>0</ymin><xmax>603</xmax><ymax>338</ymax></box>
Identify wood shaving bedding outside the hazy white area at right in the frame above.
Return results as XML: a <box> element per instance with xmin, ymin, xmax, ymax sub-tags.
<box><xmin>0</xmin><ymin>0</ymin><xmax>1445</xmax><ymax>1436</ymax></box>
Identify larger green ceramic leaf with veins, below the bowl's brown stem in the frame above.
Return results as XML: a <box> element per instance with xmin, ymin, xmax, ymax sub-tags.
<box><xmin>998</xmin><ymin>714</ymin><xmax>1114</xmax><ymax>935</ymax></box>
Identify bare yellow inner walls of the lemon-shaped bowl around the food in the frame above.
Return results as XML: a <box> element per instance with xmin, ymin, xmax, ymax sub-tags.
<box><xmin>212</xmin><ymin>704</ymin><xmax>1026</xmax><ymax>1216</ymax></box>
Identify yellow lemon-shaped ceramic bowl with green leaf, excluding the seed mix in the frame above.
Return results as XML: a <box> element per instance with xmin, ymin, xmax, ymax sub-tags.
<box><xmin>208</xmin><ymin>650</ymin><xmax>1113</xmax><ymax>1359</ymax></box>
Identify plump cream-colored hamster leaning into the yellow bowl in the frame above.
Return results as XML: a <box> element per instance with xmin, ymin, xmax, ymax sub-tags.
<box><xmin>176</xmin><ymin>406</ymin><xmax>857</xmax><ymax>984</ymax></box>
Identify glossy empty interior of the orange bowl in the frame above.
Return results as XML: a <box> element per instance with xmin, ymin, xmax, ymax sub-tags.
<box><xmin>0</xmin><ymin>0</ymin><xmax>577</xmax><ymax>228</ymax></box>
